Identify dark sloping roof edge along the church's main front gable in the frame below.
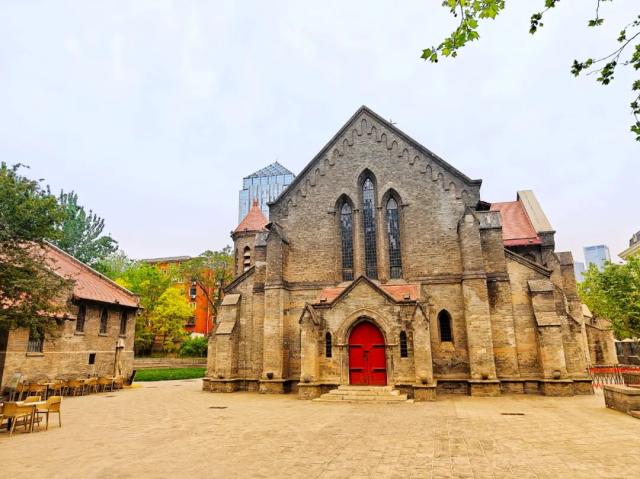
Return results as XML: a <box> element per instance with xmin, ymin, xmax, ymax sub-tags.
<box><xmin>268</xmin><ymin>105</ymin><xmax>482</xmax><ymax>205</ymax></box>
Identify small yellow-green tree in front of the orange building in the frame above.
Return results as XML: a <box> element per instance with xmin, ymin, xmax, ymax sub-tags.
<box><xmin>150</xmin><ymin>287</ymin><xmax>193</xmax><ymax>352</ymax></box>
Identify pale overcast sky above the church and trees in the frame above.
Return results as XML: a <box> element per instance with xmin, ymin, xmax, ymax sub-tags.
<box><xmin>0</xmin><ymin>0</ymin><xmax>640</xmax><ymax>260</ymax></box>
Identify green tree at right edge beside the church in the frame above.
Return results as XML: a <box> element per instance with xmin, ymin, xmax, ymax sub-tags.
<box><xmin>578</xmin><ymin>256</ymin><xmax>640</xmax><ymax>339</ymax></box>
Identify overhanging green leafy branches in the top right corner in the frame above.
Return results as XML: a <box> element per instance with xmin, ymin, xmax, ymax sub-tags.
<box><xmin>422</xmin><ymin>0</ymin><xmax>640</xmax><ymax>141</ymax></box>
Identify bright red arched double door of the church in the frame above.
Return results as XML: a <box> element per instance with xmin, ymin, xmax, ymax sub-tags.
<box><xmin>349</xmin><ymin>321</ymin><xmax>387</xmax><ymax>386</ymax></box>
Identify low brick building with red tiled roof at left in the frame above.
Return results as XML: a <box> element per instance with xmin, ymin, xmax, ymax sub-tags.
<box><xmin>0</xmin><ymin>244</ymin><xmax>140</xmax><ymax>389</ymax></box>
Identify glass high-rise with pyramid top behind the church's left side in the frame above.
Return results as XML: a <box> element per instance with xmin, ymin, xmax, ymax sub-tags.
<box><xmin>238</xmin><ymin>161</ymin><xmax>295</xmax><ymax>223</ymax></box>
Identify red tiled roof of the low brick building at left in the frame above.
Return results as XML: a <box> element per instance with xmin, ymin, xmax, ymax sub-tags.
<box><xmin>44</xmin><ymin>243</ymin><xmax>140</xmax><ymax>308</ymax></box>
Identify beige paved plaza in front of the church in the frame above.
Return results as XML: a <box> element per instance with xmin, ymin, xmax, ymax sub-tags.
<box><xmin>0</xmin><ymin>380</ymin><xmax>640</xmax><ymax>479</ymax></box>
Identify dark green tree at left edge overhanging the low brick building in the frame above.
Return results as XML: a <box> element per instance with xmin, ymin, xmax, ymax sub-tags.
<box><xmin>0</xmin><ymin>162</ymin><xmax>71</xmax><ymax>332</ymax></box>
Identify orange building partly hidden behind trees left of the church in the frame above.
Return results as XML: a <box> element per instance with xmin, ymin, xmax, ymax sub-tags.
<box><xmin>141</xmin><ymin>256</ymin><xmax>215</xmax><ymax>336</ymax></box>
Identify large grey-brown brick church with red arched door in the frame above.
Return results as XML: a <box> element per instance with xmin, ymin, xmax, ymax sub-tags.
<box><xmin>204</xmin><ymin>106</ymin><xmax>611</xmax><ymax>401</ymax></box>
